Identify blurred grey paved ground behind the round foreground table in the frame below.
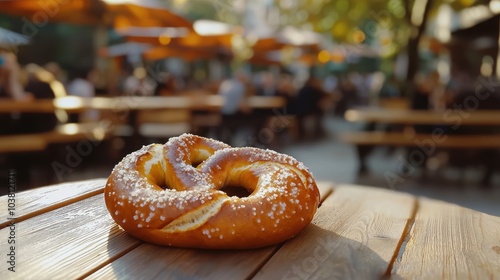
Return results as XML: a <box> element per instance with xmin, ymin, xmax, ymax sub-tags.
<box><xmin>66</xmin><ymin>113</ymin><xmax>500</xmax><ymax>216</ymax></box>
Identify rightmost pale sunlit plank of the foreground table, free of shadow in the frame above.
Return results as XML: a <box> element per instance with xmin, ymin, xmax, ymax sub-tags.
<box><xmin>393</xmin><ymin>199</ymin><xmax>500</xmax><ymax>279</ymax></box>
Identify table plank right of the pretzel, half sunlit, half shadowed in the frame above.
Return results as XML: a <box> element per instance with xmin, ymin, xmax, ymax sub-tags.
<box><xmin>254</xmin><ymin>185</ymin><xmax>415</xmax><ymax>279</ymax></box>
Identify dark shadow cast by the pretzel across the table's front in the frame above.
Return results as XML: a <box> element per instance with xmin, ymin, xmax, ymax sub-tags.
<box><xmin>106</xmin><ymin>224</ymin><xmax>402</xmax><ymax>280</ymax></box>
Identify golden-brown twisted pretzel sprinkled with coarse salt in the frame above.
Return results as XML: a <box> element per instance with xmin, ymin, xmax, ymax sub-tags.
<box><xmin>104</xmin><ymin>134</ymin><xmax>319</xmax><ymax>249</ymax></box>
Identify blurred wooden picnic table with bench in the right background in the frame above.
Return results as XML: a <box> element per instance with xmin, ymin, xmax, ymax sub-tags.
<box><xmin>339</xmin><ymin>108</ymin><xmax>500</xmax><ymax>182</ymax></box>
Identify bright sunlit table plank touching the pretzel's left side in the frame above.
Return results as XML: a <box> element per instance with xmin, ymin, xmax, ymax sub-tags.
<box><xmin>0</xmin><ymin>194</ymin><xmax>140</xmax><ymax>279</ymax></box>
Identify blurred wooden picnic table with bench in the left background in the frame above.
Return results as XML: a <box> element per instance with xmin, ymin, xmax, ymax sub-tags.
<box><xmin>0</xmin><ymin>94</ymin><xmax>286</xmax><ymax>153</ymax></box>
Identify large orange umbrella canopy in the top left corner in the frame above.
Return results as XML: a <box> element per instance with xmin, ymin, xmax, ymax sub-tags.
<box><xmin>0</xmin><ymin>0</ymin><xmax>192</xmax><ymax>28</ymax></box>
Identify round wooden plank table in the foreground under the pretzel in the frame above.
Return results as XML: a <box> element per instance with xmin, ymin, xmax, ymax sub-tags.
<box><xmin>0</xmin><ymin>179</ymin><xmax>500</xmax><ymax>280</ymax></box>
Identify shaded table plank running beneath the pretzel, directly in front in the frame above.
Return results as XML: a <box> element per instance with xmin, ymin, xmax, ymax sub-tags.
<box><xmin>88</xmin><ymin>182</ymin><xmax>332</xmax><ymax>280</ymax></box>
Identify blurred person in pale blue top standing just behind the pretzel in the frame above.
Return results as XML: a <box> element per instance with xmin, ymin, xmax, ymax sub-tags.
<box><xmin>217</xmin><ymin>70</ymin><xmax>251</xmax><ymax>143</ymax></box>
